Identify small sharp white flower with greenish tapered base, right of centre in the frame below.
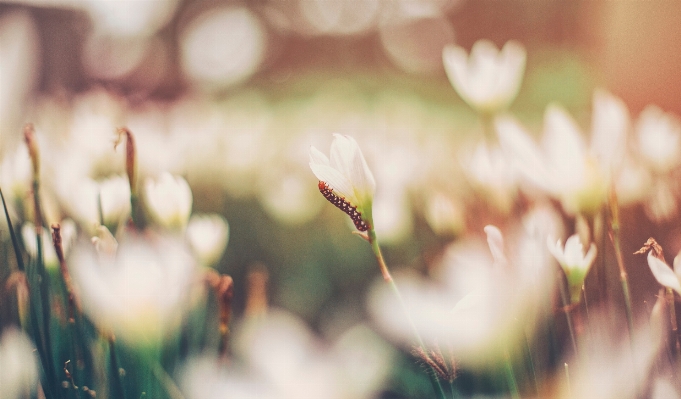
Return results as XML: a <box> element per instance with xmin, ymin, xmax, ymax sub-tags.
<box><xmin>546</xmin><ymin>234</ymin><xmax>596</xmax><ymax>303</ymax></box>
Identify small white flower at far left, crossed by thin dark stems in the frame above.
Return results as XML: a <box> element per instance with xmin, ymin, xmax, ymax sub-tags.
<box><xmin>21</xmin><ymin>219</ymin><xmax>77</xmax><ymax>268</ymax></box>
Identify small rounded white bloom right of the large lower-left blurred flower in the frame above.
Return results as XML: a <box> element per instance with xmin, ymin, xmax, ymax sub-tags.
<box><xmin>186</xmin><ymin>214</ymin><xmax>229</xmax><ymax>266</ymax></box>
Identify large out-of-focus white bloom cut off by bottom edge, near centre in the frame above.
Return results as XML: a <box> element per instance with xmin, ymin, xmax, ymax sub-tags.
<box><xmin>183</xmin><ymin>311</ymin><xmax>393</xmax><ymax>399</ymax></box>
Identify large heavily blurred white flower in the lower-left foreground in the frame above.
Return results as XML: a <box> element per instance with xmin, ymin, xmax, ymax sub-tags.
<box><xmin>69</xmin><ymin>237</ymin><xmax>197</xmax><ymax>346</ymax></box>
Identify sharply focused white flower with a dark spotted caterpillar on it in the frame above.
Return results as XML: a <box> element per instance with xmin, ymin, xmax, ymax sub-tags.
<box><xmin>310</xmin><ymin>134</ymin><xmax>376</xmax><ymax>231</ymax></box>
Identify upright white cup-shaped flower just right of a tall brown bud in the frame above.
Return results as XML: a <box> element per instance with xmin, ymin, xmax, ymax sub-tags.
<box><xmin>144</xmin><ymin>173</ymin><xmax>192</xmax><ymax>229</ymax></box>
